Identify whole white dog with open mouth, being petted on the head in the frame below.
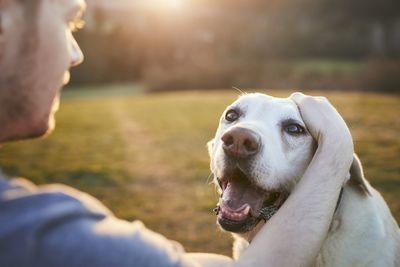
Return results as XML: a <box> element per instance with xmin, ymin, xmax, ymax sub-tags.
<box><xmin>208</xmin><ymin>93</ymin><xmax>400</xmax><ymax>267</ymax></box>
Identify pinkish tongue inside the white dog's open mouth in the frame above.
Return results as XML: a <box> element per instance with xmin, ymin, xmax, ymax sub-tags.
<box><xmin>220</xmin><ymin>180</ymin><xmax>265</xmax><ymax>215</ymax></box>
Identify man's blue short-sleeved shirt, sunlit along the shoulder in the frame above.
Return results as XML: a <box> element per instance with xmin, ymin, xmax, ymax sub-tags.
<box><xmin>0</xmin><ymin>174</ymin><xmax>197</xmax><ymax>267</ymax></box>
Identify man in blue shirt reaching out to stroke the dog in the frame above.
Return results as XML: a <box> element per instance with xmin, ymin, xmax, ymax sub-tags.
<box><xmin>0</xmin><ymin>0</ymin><xmax>353</xmax><ymax>267</ymax></box>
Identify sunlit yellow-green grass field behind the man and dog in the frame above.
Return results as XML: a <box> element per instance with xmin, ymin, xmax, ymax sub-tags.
<box><xmin>0</xmin><ymin>85</ymin><xmax>400</xmax><ymax>255</ymax></box>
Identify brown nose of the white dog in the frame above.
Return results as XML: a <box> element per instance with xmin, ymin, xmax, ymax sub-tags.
<box><xmin>221</xmin><ymin>127</ymin><xmax>261</xmax><ymax>158</ymax></box>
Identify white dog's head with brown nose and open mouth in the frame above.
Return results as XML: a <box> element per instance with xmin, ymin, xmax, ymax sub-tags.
<box><xmin>208</xmin><ymin>93</ymin><xmax>316</xmax><ymax>239</ymax></box>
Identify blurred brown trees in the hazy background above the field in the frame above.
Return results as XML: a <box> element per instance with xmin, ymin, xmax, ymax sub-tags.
<box><xmin>73</xmin><ymin>0</ymin><xmax>400</xmax><ymax>91</ymax></box>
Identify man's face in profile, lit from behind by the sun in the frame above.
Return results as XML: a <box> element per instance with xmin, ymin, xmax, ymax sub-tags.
<box><xmin>0</xmin><ymin>0</ymin><xmax>84</xmax><ymax>142</ymax></box>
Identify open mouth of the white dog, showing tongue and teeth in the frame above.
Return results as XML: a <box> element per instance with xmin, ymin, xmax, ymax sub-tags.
<box><xmin>214</xmin><ymin>168</ymin><xmax>287</xmax><ymax>233</ymax></box>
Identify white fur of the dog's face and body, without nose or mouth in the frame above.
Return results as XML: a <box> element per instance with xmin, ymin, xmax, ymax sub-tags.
<box><xmin>208</xmin><ymin>93</ymin><xmax>400</xmax><ymax>267</ymax></box>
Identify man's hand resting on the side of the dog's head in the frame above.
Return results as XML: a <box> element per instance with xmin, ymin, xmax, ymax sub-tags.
<box><xmin>290</xmin><ymin>93</ymin><xmax>353</xmax><ymax>167</ymax></box>
